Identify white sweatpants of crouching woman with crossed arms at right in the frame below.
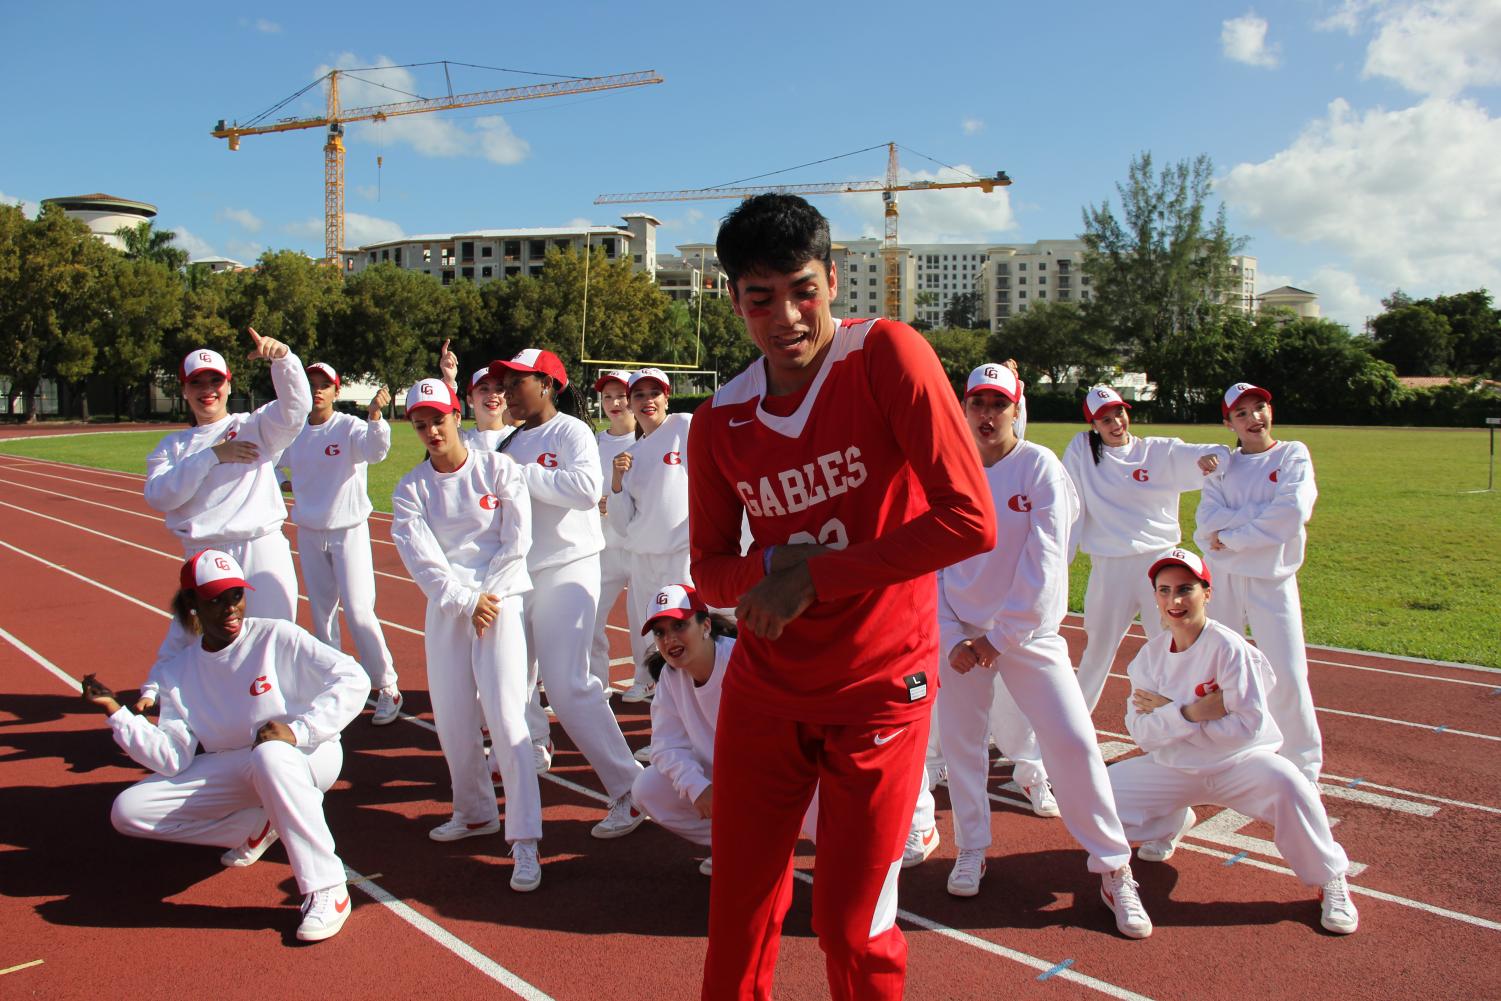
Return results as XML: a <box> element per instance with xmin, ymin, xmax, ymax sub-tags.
<box><xmin>1109</xmin><ymin>750</ymin><xmax>1349</xmax><ymax>887</ymax></box>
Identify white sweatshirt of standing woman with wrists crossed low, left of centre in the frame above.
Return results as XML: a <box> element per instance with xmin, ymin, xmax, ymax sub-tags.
<box><xmin>390</xmin><ymin>449</ymin><xmax>531</xmax><ymax>618</ymax></box>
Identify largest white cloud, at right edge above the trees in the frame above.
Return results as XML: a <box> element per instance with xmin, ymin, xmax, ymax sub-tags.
<box><xmin>1217</xmin><ymin>99</ymin><xmax>1501</xmax><ymax>313</ymax></box>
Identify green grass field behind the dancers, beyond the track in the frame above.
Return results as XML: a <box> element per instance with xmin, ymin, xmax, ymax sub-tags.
<box><xmin>0</xmin><ymin>423</ymin><xmax>1501</xmax><ymax>668</ymax></box>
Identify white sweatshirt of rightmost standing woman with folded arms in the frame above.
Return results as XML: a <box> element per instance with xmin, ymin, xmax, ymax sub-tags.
<box><xmin>1193</xmin><ymin>441</ymin><xmax>1318</xmax><ymax>579</ymax></box>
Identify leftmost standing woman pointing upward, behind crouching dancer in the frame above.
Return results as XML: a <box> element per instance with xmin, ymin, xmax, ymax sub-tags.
<box><xmin>135</xmin><ymin>329</ymin><xmax>312</xmax><ymax>713</ymax></box>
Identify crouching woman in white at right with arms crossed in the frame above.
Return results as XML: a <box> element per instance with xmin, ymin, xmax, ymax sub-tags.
<box><xmin>1109</xmin><ymin>549</ymin><xmax>1360</xmax><ymax>935</ymax></box>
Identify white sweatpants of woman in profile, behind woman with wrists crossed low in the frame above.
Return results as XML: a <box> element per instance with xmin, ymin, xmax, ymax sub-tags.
<box><xmin>525</xmin><ymin>555</ymin><xmax>650</xmax><ymax>800</ymax></box>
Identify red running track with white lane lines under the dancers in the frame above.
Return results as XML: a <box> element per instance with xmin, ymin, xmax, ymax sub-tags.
<box><xmin>0</xmin><ymin>456</ymin><xmax>1501</xmax><ymax>1001</ymax></box>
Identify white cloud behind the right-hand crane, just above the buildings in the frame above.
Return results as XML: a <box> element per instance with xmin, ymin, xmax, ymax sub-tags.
<box><xmin>846</xmin><ymin>164</ymin><xmax>1016</xmax><ymax>243</ymax></box>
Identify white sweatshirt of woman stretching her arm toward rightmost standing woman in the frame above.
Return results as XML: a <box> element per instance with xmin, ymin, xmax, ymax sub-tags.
<box><xmin>1063</xmin><ymin>431</ymin><xmax>1229</xmax><ymax>557</ymax></box>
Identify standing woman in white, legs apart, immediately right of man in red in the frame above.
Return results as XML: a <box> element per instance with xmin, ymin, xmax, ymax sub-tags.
<box><xmin>938</xmin><ymin>365</ymin><xmax>1151</xmax><ymax>938</ymax></box>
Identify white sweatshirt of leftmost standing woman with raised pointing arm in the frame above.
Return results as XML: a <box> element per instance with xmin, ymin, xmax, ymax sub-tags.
<box><xmin>146</xmin><ymin>353</ymin><xmax>312</xmax><ymax>552</ymax></box>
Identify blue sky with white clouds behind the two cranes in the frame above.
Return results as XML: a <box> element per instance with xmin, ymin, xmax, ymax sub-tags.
<box><xmin>0</xmin><ymin>0</ymin><xmax>1501</xmax><ymax>327</ymax></box>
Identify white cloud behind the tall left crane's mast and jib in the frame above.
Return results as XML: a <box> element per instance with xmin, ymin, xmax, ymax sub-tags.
<box><xmin>315</xmin><ymin>53</ymin><xmax>531</xmax><ymax>165</ymax></box>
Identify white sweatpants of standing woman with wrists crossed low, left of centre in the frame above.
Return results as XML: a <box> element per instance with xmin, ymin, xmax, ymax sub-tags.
<box><xmin>423</xmin><ymin>594</ymin><xmax>542</xmax><ymax>842</ymax></box>
